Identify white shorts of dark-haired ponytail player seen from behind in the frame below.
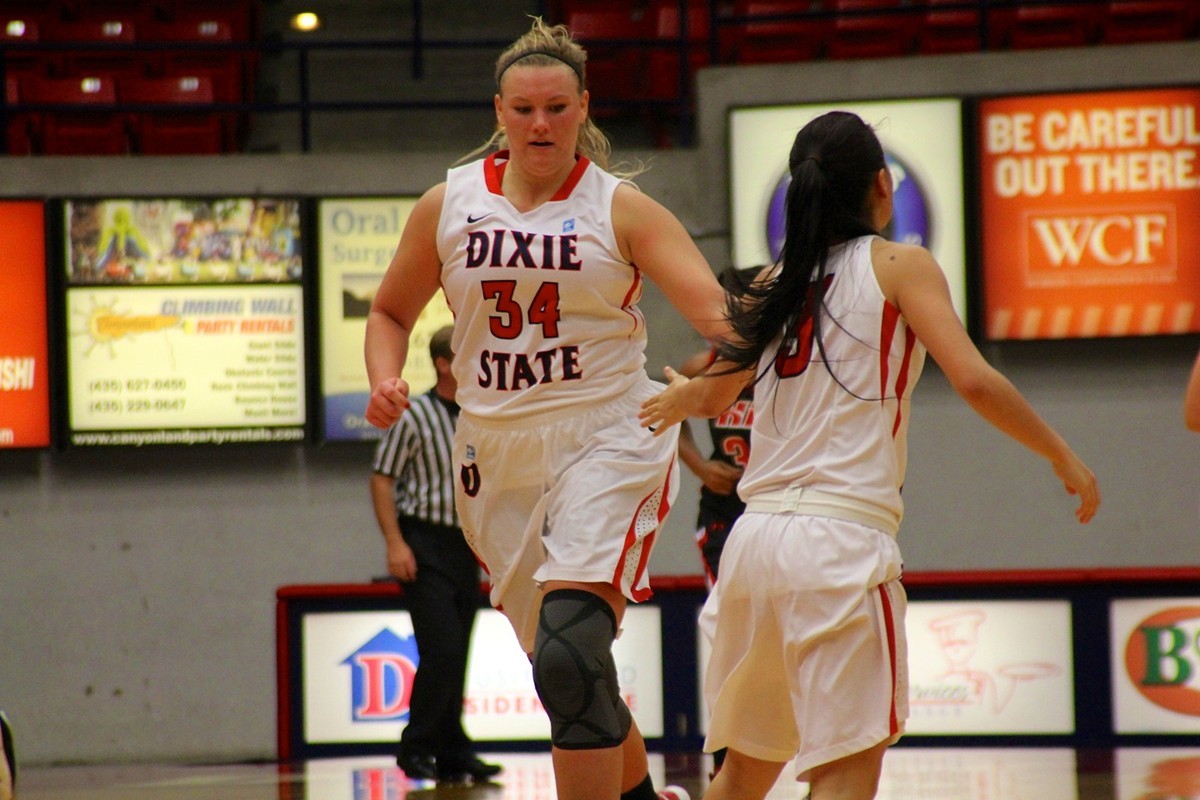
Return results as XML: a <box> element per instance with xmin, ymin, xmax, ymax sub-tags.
<box><xmin>701</xmin><ymin>512</ymin><xmax>908</xmax><ymax>781</ymax></box>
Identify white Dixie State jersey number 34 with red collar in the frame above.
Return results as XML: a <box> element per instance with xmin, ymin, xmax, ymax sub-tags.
<box><xmin>438</xmin><ymin>151</ymin><xmax>646</xmax><ymax>420</ymax></box>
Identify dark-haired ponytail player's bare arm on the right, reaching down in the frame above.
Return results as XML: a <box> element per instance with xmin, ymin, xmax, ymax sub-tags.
<box><xmin>874</xmin><ymin>240</ymin><xmax>1100</xmax><ymax>523</ymax></box>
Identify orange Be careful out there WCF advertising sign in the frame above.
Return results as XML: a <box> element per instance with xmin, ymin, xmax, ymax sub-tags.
<box><xmin>978</xmin><ymin>89</ymin><xmax>1200</xmax><ymax>341</ymax></box>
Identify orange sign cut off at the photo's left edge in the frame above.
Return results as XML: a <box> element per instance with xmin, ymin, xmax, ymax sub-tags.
<box><xmin>0</xmin><ymin>200</ymin><xmax>50</xmax><ymax>449</ymax></box>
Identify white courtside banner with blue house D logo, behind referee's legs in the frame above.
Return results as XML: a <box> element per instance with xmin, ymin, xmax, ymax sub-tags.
<box><xmin>301</xmin><ymin>606</ymin><xmax>664</xmax><ymax>745</ymax></box>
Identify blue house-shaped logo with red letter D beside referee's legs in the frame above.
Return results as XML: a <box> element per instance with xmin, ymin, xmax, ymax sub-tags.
<box><xmin>342</xmin><ymin>628</ymin><xmax>419</xmax><ymax>722</ymax></box>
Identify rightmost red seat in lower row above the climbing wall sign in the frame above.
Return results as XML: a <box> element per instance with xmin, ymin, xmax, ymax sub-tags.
<box><xmin>118</xmin><ymin>76</ymin><xmax>224</xmax><ymax>156</ymax></box>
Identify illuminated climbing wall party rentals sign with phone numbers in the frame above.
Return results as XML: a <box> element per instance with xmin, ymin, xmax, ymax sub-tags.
<box><xmin>64</xmin><ymin>198</ymin><xmax>306</xmax><ymax>445</ymax></box>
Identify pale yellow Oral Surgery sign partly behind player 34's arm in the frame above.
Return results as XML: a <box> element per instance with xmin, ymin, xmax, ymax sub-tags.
<box><xmin>317</xmin><ymin>197</ymin><xmax>454</xmax><ymax>440</ymax></box>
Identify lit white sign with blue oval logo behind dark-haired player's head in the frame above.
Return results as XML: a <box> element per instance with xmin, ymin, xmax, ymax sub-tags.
<box><xmin>715</xmin><ymin>100</ymin><xmax>967</xmax><ymax>323</ymax></box>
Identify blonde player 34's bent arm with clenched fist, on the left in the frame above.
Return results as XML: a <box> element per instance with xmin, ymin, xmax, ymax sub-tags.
<box><xmin>364</xmin><ymin>184</ymin><xmax>445</xmax><ymax>428</ymax></box>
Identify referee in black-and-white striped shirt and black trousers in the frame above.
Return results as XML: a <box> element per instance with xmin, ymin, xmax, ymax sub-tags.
<box><xmin>371</xmin><ymin>326</ymin><xmax>500</xmax><ymax>782</ymax></box>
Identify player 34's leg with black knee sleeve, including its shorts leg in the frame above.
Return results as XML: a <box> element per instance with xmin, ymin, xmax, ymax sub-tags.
<box><xmin>534</xmin><ymin>386</ymin><xmax>678</xmax><ymax>800</ymax></box>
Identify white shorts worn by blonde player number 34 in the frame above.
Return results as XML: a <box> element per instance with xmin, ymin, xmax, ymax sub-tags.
<box><xmin>454</xmin><ymin>379</ymin><xmax>679</xmax><ymax>652</ymax></box>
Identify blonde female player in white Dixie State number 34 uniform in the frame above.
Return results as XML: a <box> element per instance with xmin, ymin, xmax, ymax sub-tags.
<box><xmin>366</xmin><ymin>19</ymin><xmax>728</xmax><ymax>800</ymax></box>
